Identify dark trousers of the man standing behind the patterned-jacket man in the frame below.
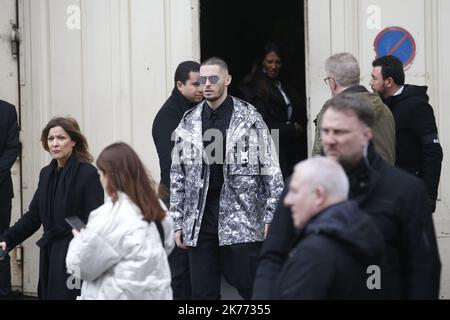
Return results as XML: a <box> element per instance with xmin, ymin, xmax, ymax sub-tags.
<box><xmin>169</xmin><ymin>246</ymin><xmax>192</xmax><ymax>300</ymax></box>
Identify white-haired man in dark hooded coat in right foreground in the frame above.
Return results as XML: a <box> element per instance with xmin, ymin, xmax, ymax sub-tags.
<box><xmin>275</xmin><ymin>157</ymin><xmax>384</xmax><ymax>300</ymax></box>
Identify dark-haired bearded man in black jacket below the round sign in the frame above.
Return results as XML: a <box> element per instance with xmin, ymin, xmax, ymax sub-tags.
<box><xmin>371</xmin><ymin>56</ymin><xmax>443</xmax><ymax>212</ymax></box>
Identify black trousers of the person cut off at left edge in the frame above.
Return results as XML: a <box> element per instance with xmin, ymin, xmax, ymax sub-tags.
<box><xmin>0</xmin><ymin>200</ymin><xmax>11</xmax><ymax>298</ymax></box>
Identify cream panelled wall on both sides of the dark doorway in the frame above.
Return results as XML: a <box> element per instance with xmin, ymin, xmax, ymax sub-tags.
<box><xmin>15</xmin><ymin>0</ymin><xmax>450</xmax><ymax>298</ymax></box>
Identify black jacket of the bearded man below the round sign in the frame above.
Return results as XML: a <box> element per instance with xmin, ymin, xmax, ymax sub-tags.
<box><xmin>385</xmin><ymin>85</ymin><xmax>443</xmax><ymax>211</ymax></box>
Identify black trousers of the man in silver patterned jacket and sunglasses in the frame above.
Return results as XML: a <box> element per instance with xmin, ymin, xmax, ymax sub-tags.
<box><xmin>189</xmin><ymin>233</ymin><xmax>262</xmax><ymax>300</ymax></box>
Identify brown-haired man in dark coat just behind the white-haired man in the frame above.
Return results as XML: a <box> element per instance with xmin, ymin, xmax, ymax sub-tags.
<box><xmin>254</xmin><ymin>95</ymin><xmax>441</xmax><ymax>299</ymax></box>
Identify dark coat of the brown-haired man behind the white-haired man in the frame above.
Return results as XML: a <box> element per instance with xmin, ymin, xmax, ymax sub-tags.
<box><xmin>253</xmin><ymin>147</ymin><xmax>441</xmax><ymax>299</ymax></box>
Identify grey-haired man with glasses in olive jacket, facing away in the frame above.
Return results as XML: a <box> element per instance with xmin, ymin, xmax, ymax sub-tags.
<box><xmin>313</xmin><ymin>53</ymin><xmax>395</xmax><ymax>165</ymax></box>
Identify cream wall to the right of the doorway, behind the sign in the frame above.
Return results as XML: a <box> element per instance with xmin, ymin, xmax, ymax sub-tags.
<box><xmin>306</xmin><ymin>0</ymin><xmax>450</xmax><ymax>298</ymax></box>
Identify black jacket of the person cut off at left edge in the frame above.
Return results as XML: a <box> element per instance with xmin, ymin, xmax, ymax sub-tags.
<box><xmin>0</xmin><ymin>100</ymin><xmax>20</xmax><ymax>201</ymax></box>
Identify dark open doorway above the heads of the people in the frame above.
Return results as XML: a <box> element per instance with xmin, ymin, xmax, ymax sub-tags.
<box><xmin>200</xmin><ymin>0</ymin><xmax>306</xmax><ymax>101</ymax></box>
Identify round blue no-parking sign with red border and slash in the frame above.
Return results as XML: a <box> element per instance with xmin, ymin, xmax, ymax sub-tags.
<box><xmin>373</xmin><ymin>27</ymin><xmax>416</xmax><ymax>70</ymax></box>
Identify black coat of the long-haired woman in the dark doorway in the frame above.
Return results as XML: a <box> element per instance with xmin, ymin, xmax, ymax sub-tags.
<box><xmin>240</xmin><ymin>79</ymin><xmax>307</xmax><ymax>178</ymax></box>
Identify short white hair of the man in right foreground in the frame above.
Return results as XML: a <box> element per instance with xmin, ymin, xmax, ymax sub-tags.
<box><xmin>295</xmin><ymin>156</ymin><xmax>350</xmax><ymax>201</ymax></box>
